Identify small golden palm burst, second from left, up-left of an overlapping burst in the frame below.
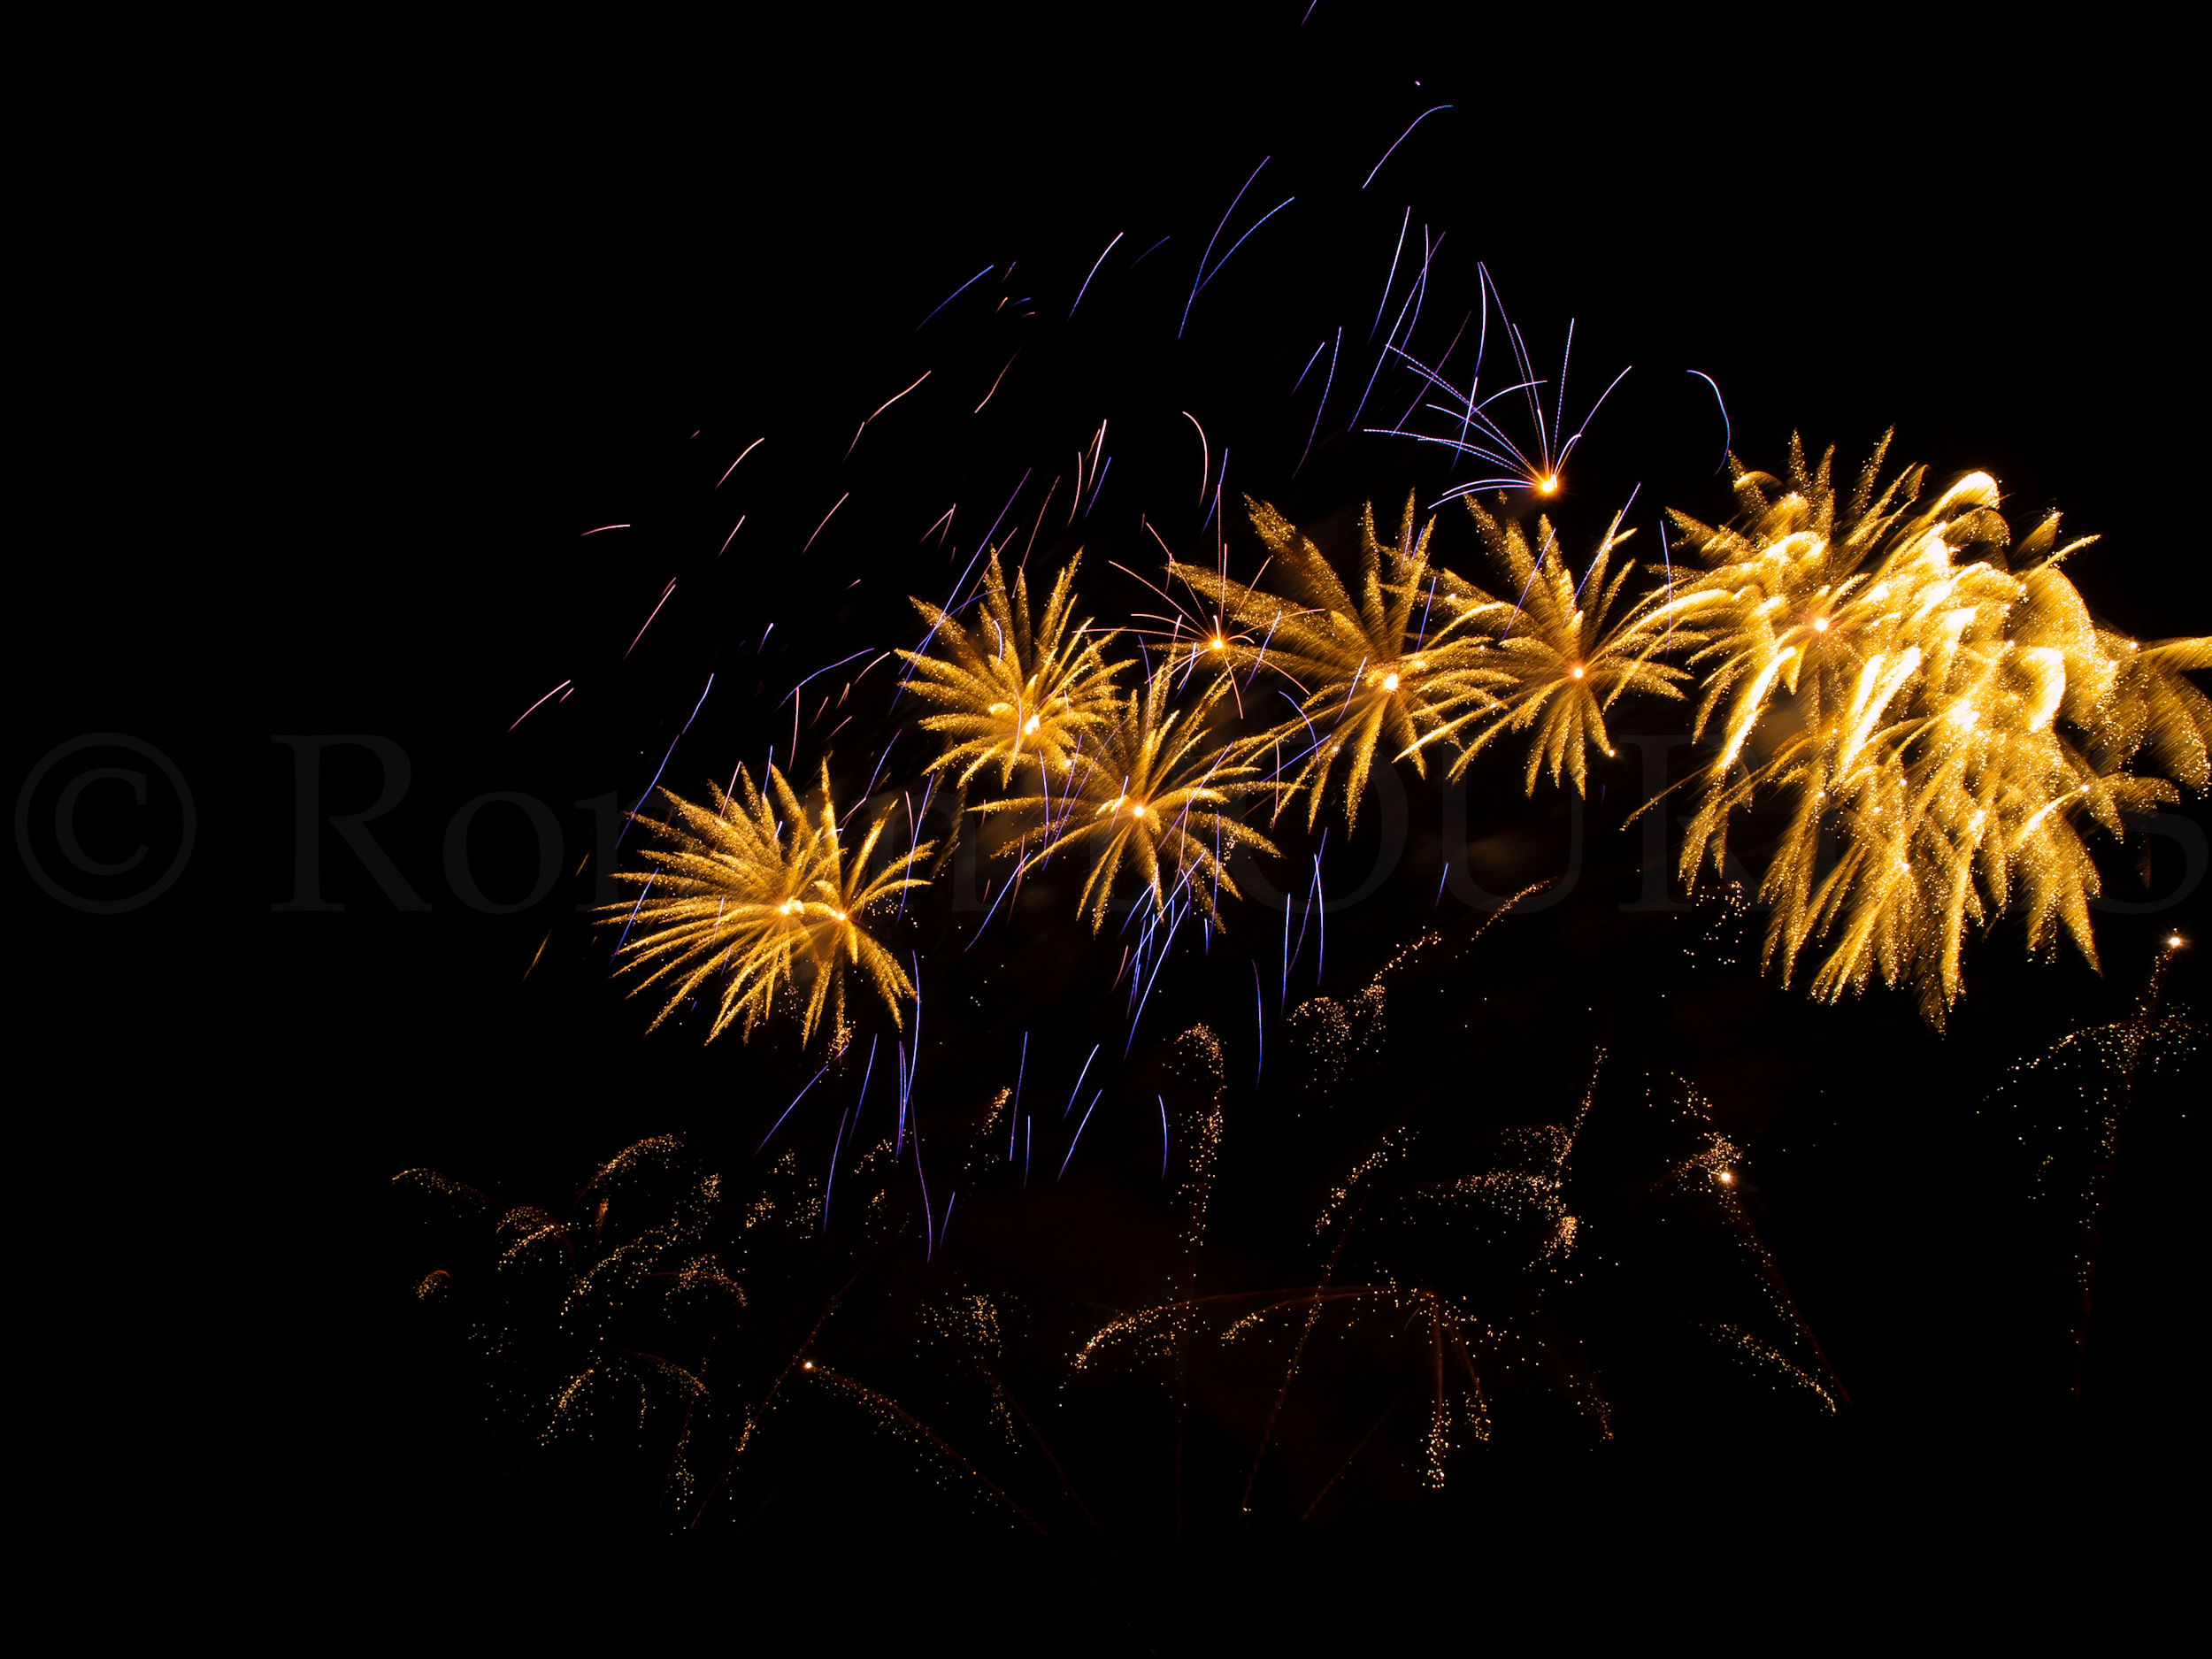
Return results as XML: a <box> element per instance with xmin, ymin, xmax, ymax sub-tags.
<box><xmin>898</xmin><ymin>551</ymin><xmax>1124</xmax><ymax>790</ymax></box>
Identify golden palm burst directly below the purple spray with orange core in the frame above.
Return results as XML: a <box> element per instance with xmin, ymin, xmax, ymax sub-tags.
<box><xmin>1420</xmin><ymin>498</ymin><xmax>1688</xmax><ymax>795</ymax></box>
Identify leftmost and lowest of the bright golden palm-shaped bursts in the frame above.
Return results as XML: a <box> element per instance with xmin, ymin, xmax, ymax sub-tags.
<box><xmin>606</xmin><ymin>765</ymin><xmax>933</xmax><ymax>1042</ymax></box>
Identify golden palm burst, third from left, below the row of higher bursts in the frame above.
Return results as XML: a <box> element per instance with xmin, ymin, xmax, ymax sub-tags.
<box><xmin>978</xmin><ymin>662</ymin><xmax>1277</xmax><ymax>933</ymax></box>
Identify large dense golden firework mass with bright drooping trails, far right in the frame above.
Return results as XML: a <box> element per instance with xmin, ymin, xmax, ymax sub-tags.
<box><xmin>1635</xmin><ymin>441</ymin><xmax>2212</xmax><ymax>1025</ymax></box>
